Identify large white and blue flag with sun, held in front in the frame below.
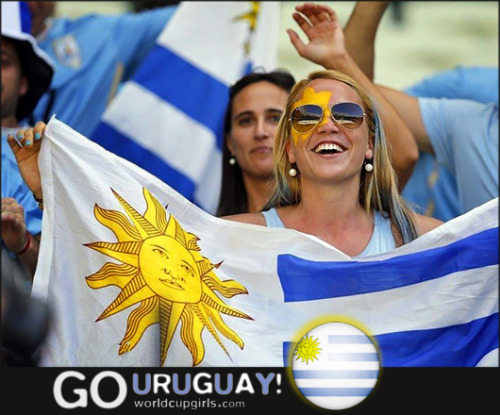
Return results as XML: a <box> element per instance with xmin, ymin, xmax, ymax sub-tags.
<box><xmin>33</xmin><ymin>118</ymin><xmax>498</xmax><ymax>367</ymax></box>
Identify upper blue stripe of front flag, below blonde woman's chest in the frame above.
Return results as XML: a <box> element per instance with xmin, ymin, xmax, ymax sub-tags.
<box><xmin>278</xmin><ymin>228</ymin><xmax>498</xmax><ymax>302</ymax></box>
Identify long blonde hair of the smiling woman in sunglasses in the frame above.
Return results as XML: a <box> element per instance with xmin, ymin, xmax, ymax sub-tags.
<box><xmin>264</xmin><ymin>70</ymin><xmax>418</xmax><ymax>243</ymax></box>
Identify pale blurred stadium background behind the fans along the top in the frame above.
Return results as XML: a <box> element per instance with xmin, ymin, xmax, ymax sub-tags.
<box><xmin>57</xmin><ymin>0</ymin><xmax>499</xmax><ymax>88</ymax></box>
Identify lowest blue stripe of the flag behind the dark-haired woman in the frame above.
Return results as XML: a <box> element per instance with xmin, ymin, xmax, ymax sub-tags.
<box><xmin>93</xmin><ymin>122</ymin><xmax>195</xmax><ymax>202</ymax></box>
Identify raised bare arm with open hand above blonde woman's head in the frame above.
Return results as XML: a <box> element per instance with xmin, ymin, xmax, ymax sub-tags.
<box><xmin>287</xmin><ymin>3</ymin><xmax>418</xmax><ymax>190</ymax></box>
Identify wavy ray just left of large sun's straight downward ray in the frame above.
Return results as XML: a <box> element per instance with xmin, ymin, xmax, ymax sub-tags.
<box><xmin>118</xmin><ymin>297</ymin><xmax>159</xmax><ymax>354</ymax></box>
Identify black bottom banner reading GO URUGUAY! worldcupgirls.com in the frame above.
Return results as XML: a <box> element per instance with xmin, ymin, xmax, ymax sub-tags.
<box><xmin>0</xmin><ymin>367</ymin><xmax>500</xmax><ymax>415</ymax></box>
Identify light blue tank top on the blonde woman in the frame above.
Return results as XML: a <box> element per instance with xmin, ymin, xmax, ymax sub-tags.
<box><xmin>261</xmin><ymin>208</ymin><xmax>396</xmax><ymax>257</ymax></box>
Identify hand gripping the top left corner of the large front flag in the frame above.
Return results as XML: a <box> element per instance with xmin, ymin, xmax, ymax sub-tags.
<box><xmin>7</xmin><ymin>121</ymin><xmax>47</xmax><ymax>199</ymax></box>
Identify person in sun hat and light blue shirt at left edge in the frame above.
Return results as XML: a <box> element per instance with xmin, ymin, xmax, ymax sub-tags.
<box><xmin>1</xmin><ymin>2</ymin><xmax>54</xmax><ymax>290</ymax></box>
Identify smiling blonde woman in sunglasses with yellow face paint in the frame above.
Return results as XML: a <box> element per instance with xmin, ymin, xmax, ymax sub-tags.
<box><xmin>225</xmin><ymin>70</ymin><xmax>442</xmax><ymax>257</ymax></box>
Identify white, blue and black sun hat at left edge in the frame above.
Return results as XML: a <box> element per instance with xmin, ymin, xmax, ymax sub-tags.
<box><xmin>2</xmin><ymin>1</ymin><xmax>55</xmax><ymax>120</ymax></box>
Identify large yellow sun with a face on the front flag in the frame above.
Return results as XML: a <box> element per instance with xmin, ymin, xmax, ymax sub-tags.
<box><xmin>85</xmin><ymin>188</ymin><xmax>251</xmax><ymax>366</ymax></box>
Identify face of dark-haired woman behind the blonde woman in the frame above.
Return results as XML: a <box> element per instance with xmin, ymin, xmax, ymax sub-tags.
<box><xmin>227</xmin><ymin>81</ymin><xmax>288</xmax><ymax>180</ymax></box>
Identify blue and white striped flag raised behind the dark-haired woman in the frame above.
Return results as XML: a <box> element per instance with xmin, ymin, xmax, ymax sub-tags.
<box><xmin>92</xmin><ymin>1</ymin><xmax>280</xmax><ymax>213</ymax></box>
